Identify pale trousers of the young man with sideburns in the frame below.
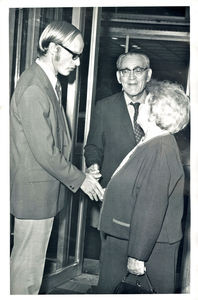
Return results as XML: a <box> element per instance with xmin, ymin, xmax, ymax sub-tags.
<box><xmin>10</xmin><ymin>217</ymin><xmax>54</xmax><ymax>295</ymax></box>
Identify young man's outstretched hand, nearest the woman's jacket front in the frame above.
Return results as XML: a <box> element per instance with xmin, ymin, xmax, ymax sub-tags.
<box><xmin>80</xmin><ymin>173</ymin><xmax>104</xmax><ymax>201</ymax></box>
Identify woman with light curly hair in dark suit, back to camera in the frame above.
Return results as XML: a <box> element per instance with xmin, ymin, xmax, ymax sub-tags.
<box><xmin>97</xmin><ymin>81</ymin><xmax>189</xmax><ymax>293</ymax></box>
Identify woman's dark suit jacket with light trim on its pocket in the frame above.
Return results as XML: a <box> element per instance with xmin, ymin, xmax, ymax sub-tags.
<box><xmin>100</xmin><ymin>135</ymin><xmax>184</xmax><ymax>261</ymax></box>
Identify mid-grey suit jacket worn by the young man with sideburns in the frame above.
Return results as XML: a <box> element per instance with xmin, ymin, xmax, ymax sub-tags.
<box><xmin>10</xmin><ymin>63</ymin><xmax>85</xmax><ymax>219</ymax></box>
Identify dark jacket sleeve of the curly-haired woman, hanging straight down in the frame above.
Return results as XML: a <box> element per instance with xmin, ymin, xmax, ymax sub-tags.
<box><xmin>128</xmin><ymin>147</ymin><xmax>170</xmax><ymax>261</ymax></box>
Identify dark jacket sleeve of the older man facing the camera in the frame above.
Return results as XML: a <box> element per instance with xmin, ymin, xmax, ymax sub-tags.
<box><xmin>84</xmin><ymin>101</ymin><xmax>104</xmax><ymax>167</ymax></box>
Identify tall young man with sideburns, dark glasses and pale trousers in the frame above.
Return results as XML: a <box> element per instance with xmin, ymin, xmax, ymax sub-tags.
<box><xmin>10</xmin><ymin>22</ymin><xmax>102</xmax><ymax>294</ymax></box>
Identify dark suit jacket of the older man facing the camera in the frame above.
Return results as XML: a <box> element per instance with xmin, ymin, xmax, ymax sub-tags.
<box><xmin>85</xmin><ymin>92</ymin><xmax>136</xmax><ymax>187</ymax></box>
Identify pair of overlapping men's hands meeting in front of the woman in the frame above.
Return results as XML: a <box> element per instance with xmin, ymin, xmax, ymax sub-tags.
<box><xmin>81</xmin><ymin>164</ymin><xmax>104</xmax><ymax>201</ymax></box>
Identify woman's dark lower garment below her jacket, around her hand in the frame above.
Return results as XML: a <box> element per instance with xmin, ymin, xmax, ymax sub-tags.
<box><xmin>94</xmin><ymin>234</ymin><xmax>180</xmax><ymax>294</ymax></box>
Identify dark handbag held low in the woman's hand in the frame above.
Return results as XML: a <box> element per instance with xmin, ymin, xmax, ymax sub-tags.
<box><xmin>114</xmin><ymin>273</ymin><xmax>156</xmax><ymax>294</ymax></box>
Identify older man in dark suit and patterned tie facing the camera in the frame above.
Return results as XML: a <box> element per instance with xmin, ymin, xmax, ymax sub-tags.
<box><xmin>85</xmin><ymin>52</ymin><xmax>152</xmax><ymax>227</ymax></box>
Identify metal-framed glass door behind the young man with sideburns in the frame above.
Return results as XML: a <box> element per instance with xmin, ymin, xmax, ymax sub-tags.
<box><xmin>9</xmin><ymin>7</ymin><xmax>99</xmax><ymax>293</ymax></box>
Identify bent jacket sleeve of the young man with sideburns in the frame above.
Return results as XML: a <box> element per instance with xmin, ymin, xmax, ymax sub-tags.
<box><xmin>18</xmin><ymin>86</ymin><xmax>85</xmax><ymax>192</ymax></box>
